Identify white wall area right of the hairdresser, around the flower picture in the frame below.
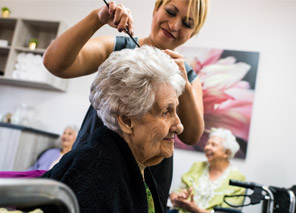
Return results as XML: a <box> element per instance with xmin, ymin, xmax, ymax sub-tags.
<box><xmin>173</xmin><ymin>0</ymin><xmax>296</xmax><ymax>212</ymax></box>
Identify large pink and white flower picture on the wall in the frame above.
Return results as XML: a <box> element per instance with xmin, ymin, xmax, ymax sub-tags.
<box><xmin>176</xmin><ymin>46</ymin><xmax>259</xmax><ymax>158</ymax></box>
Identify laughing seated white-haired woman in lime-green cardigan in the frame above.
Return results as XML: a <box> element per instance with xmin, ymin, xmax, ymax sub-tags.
<box><xmin>170</xmin><ymin>128</ymin><xmax>245</xmax><ymax>213</ymax></box>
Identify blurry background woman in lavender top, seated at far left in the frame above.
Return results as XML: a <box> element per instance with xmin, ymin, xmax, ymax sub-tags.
<box><xmin>28</xmin><ymin>125</ymin><xmax>78</xmax><ymax>170</ymax></box>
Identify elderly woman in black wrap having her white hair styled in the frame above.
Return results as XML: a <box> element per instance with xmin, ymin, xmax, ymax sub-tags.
<box><xmin>43</xmin><ymin>46</ymin><xmax>186</xmax><ymax>213</ymax></box>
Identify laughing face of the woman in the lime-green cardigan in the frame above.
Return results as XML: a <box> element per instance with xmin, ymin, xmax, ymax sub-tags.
<box><xmin>204</xmin><ymin>136</ymin><xmax>228</xmax><ymax>163</ymax></box>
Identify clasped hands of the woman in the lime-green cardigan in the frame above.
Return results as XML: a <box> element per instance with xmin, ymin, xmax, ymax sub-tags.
<box><xmin>171</xmin><ymin>188</ymin><xmax>199</xmax><ymax>212</ymax></box>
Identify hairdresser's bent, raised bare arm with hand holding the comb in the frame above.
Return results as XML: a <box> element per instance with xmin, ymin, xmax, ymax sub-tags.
<box><xmin>43</xmin><ymin>2</ymin><xmax>133</xmax><ymax>78</ymax></box>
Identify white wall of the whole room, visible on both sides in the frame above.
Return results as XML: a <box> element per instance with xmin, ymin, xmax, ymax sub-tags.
<box><xmin>0</xmin><ymin>0</ymin><xmax>296</xmax><ymax>212</ymax></box>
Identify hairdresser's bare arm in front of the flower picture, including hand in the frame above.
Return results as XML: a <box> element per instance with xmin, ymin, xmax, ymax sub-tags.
<box><xmin>165</xmin><ymin>50</ymin><xmax>204</xmax><ymax>145</ymax></box>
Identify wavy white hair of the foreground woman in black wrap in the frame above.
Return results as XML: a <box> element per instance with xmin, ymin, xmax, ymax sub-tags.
<box><xmin>89</xmin><ymin>45</ymin><xmax>186</xmax><ymax>133</ymax></box>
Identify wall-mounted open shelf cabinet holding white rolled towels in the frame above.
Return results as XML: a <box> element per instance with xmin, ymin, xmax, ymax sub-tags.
<box><xmin>0</xmin><ymin>18</ymin><xmax>68</xmax><ymax>91</ymax></box>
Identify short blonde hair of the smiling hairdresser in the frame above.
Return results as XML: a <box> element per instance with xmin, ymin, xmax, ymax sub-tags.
<box><xmin>154</xmin><ymin>0</ymin><xmax>209</xmax><ymax>37</ymax></box>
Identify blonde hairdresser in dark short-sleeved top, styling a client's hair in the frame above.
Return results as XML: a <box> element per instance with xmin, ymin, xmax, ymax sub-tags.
<box><xmin>44</xmin><ymin>0</ymin><xmax>208</xmax><ymax>207</ymax></box>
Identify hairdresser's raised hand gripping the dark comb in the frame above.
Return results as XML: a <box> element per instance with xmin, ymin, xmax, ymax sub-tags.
<box><xmin>98</xmin><ymin>1</ymin><xmax>134</xmax><ymax>35</ymax></box>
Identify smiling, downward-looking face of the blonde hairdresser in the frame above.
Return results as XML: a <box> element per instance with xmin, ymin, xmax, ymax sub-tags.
<box><xmin>150</xmin><ymin>0</ymin><xmax>194</xmax><ymax>50</ymax></box>
